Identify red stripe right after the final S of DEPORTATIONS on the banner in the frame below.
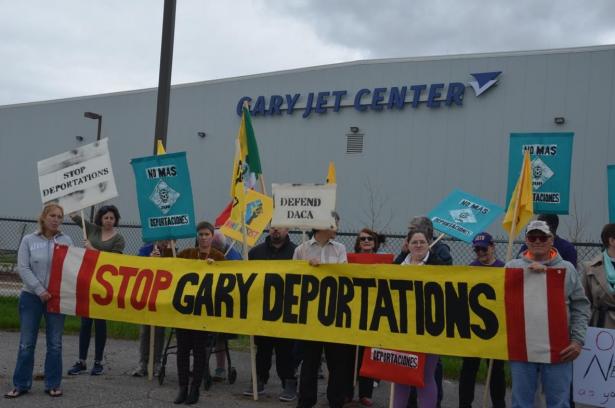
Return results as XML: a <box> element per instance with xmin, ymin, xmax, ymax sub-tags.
<box><xmin>504</xmin><ymin>268</ymin><xmax>527</xmax><ymax>361</ymax></box>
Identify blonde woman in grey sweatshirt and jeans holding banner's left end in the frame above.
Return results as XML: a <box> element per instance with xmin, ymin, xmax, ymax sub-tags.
<box><xmin>4</xmin><ymin>204</ymin><xmax>73</xmax><ymax>398</ymax></box>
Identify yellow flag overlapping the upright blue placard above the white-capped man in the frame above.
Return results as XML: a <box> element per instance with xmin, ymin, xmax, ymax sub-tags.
<box><xmin>502</xmin><ymin>150</ymin><xmax>534</xmax><ymax>238</ymax></box>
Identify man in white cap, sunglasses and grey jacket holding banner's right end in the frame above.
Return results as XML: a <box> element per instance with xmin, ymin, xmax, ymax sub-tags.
<box><xmin>506</xmin><ymin>220</ymin><xmax>590</xmax><ymax>408</ymax></box>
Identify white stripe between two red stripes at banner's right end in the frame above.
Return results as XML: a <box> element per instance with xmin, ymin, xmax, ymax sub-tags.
<box><xmin>523</xmin><ymin>269</ymin><xmax>551</xmax><ymax>363</ymax></box>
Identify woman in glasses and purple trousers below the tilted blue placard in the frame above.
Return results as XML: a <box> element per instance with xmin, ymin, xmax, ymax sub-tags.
<box><xmin>393</xmin><ymin>227</ymin><xmax>444</xmax><ymax>408</ymax></box>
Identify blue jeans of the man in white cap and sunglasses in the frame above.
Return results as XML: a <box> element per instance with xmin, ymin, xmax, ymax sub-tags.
<box><xmin>510</xmin><ymin>361</ymin><xmax>572</xmax><ymax>408</ymax></box>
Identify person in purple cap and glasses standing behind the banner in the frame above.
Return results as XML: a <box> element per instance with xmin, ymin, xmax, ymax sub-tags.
<box><xmin>459</xmin><ymin>232</ymin><xmax>506</xmax><ymax>408</ymax></box>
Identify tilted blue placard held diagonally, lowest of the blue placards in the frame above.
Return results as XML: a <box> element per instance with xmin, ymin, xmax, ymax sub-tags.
<box><xmin>427</xmin><ymin>190</ymin><xmax>504</xmax><ymax>242</ymax></box>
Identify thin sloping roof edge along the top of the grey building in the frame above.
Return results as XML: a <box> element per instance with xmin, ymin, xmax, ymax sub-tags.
<box><xmin>0</xmin><ymin>44</ymin><xmax>615</xmax><ymax>109</ymax></box>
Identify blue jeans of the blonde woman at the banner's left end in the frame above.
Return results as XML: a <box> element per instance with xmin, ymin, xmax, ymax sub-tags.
<box><xmin>13</xmin><ymin>291</ymin><xmax>64</xmax><ymax>391</ymax></box>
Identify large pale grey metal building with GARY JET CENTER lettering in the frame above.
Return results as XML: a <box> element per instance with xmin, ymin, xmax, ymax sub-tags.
<box><xmin>0</xmin><ymin>46</ymin><xmax>615</xmax><ymax>241</ymax></box>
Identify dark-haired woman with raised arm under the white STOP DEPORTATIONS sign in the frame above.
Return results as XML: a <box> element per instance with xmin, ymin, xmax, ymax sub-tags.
<box><xmin>68</xmin><ymin>205</ymin><xmax>126</xmax><ymax>375</ymax></box>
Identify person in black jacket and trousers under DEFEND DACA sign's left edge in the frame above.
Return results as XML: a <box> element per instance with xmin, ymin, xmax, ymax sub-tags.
<box><xmin>243</xmin><ymin>227</ymin><xmax>297</xmax><ymax>402</ymax></box>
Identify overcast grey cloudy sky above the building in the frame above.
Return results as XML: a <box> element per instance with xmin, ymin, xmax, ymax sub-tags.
<box><xmin>0</xmin><ymin>0</ymin><xmax>615</xmax><ymax>105</ymax></box>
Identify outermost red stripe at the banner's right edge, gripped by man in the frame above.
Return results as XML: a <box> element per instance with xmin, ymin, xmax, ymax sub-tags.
<box><xmin>547</xmin><ymin>269</ymin><xmax>570</xmax><ymax>363</ymax></box>
